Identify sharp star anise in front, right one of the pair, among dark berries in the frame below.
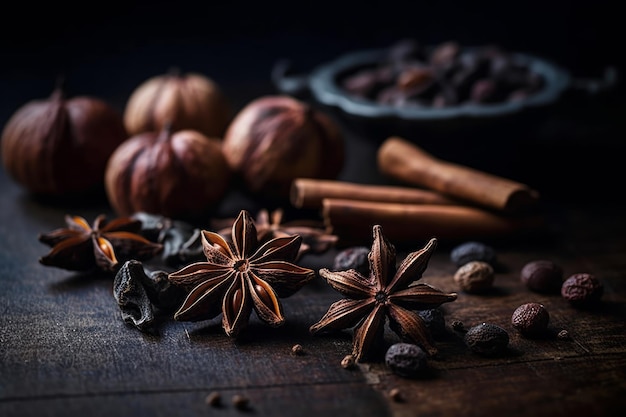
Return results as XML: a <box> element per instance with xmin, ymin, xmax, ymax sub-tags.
<box><xmin>310</xmin><ymin>225</ymin><xmax>457</xmax><ymax>361</ymax></box>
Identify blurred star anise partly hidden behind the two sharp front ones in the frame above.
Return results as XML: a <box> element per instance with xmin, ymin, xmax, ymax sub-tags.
<box><xmin>215</xmin><ymin>208</ymin><xmax>338</xmax><ymax>259</ymax></box>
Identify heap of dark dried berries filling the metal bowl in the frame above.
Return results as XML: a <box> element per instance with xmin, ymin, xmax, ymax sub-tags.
<box><xmin>340</xmin><ymin>39</ymin><xmax>545</xmax><ymax>108</ymax></box>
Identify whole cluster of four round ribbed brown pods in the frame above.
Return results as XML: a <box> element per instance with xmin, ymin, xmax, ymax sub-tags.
<box><xmin>1</xmin><ymin>69</ymin><xmax>344</xmax><ymax>219</ymax></box>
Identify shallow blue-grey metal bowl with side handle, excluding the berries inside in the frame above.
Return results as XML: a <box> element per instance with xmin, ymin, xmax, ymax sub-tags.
<box><xmin>272</xmin><ymin>49</ymin><xmax>572</xmax><ymax>140</ymax></box>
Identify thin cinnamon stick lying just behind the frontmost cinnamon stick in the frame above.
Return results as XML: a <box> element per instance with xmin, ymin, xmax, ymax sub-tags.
<box><xmin>290</xmin><ymin>178</ymin><xmax>461</xmax><ymax>208</ymax></box>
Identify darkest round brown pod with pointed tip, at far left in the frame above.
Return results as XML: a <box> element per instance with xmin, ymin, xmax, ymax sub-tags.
<box><xmin>2</xmin><ymin>86</ymin><xmax>128</xmax><ymax>196</ymax></box>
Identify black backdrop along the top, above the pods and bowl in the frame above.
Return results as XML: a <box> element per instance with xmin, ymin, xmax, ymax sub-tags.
<box><xmin>0</xmin><ymin>0</ymin><xmax>624</xmax><ymax>105</ymax></box>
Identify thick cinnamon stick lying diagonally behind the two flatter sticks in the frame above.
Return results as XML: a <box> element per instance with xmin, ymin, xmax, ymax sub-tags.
<box><xmin>377</xmin><ymin>136</ymin><xmax>539</xmax><ymax>212</ymax></box>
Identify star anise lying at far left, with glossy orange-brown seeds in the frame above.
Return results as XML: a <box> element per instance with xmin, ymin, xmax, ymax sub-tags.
<box><xmin>39</xmin><ymin>214</ymin><xmax>163</xmax><ymax>272</ymax></box>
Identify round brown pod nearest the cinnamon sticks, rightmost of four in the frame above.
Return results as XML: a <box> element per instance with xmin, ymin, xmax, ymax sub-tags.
<box><xmin>222</xmin><ymin>96</ymin><xmax>344</xmax><ymax>198</ymax></box>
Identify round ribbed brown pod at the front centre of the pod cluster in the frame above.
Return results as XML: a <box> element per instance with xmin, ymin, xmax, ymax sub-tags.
<box><xmin>105</xmin><ymin>126</ymin><xmax>231</xmax><ymax>219</ymax></box>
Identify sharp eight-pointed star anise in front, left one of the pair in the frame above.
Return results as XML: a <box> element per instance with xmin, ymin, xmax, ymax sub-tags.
<box><xmin>169</xmin><ymin>210</ymin><xmax>315</xmax><ymax>336</ymax></box>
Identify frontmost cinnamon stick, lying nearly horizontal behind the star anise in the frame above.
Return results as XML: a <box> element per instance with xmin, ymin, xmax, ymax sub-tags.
<box><xmin>322</xmin><ymin>198</ymin><xmax>542</xmax><ymax>243</ymax></box>
